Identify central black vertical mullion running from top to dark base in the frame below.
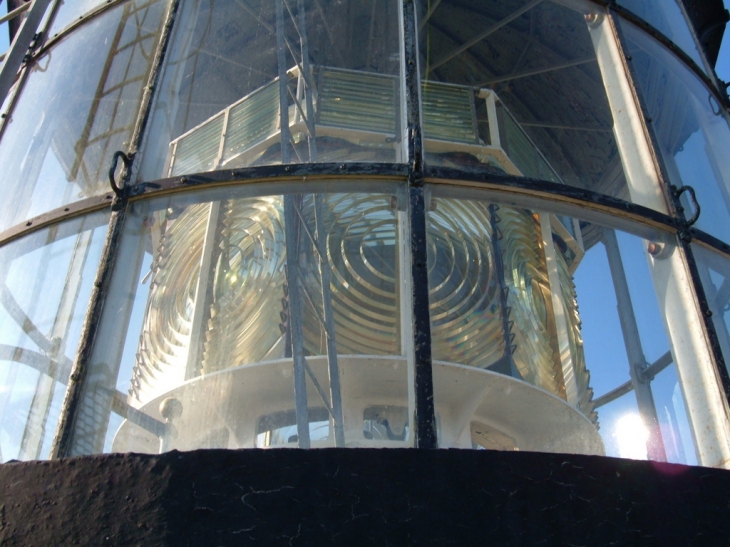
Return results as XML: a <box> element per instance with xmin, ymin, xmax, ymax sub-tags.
<box><xmin>401</xmin><ymin>0</ymin><xmax>438</xmax><ymax>448</ymax></box>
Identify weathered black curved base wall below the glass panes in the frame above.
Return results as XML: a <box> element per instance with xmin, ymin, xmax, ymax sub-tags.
<box><xmin>0</xmin><ymin>449</ymin><xmax>730</xmax><ymax>547</ymax></box>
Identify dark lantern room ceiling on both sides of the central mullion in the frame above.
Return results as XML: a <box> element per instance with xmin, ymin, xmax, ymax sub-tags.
<box><xmin>134</xmin><ymin>0</ymin><xmax>724</xmax><ymax>206</ymax></box>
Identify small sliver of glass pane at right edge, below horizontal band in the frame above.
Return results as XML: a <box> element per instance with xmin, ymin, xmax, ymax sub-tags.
<box><xmin>692</xmin><ymin>244</ymin><xmax>730</xmax><ymax>382</ymax></box>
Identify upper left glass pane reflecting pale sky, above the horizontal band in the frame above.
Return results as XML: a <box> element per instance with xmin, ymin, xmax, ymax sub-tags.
<box><xmin>0</xmin><ymin>0</ymin><xmax>165</xmax><ymax>229</ymax></box>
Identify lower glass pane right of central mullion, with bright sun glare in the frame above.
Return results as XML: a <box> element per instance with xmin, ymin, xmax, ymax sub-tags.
<box><xmin>427</xmin><ymin>186</ymin><xmax>727</xmax><ymax>464</ymax></box>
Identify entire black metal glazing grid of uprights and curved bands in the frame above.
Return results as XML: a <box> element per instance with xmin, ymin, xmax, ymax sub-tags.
<box><xmin>0</xmin><ymin>0</ymin><xmax>716</xmax><ymax>458</ymax></box>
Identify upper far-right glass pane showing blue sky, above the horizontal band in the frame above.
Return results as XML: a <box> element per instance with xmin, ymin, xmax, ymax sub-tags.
<box><xmin>622</xmin><ymin>23</ymin><xmax>730</xmax><ymax>242</ymax></box>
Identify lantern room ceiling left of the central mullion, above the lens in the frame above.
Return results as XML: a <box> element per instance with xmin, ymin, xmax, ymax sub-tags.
<box><xmin>169</xmin><ymin>0</ymin><xmax>399</xmax><ymax>134</ymax></box>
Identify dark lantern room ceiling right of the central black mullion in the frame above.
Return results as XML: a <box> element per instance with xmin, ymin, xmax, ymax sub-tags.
<box><xmin>420</xmin><ymin>0</ymin><xmax>625</xmax><ymax>197</ymax></box>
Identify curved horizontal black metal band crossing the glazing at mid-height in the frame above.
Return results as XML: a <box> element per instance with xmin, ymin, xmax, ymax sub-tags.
<box><xmin>0</xmin><ymin>163</ymin><xmax>730</xmax><ymax>256</ymax></box>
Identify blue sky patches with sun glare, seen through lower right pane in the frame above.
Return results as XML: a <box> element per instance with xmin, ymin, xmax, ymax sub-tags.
<box><xmin>575</xmin><ymin>232</ymin><xmax>697</xmax><ymax>465</ymax></box>
